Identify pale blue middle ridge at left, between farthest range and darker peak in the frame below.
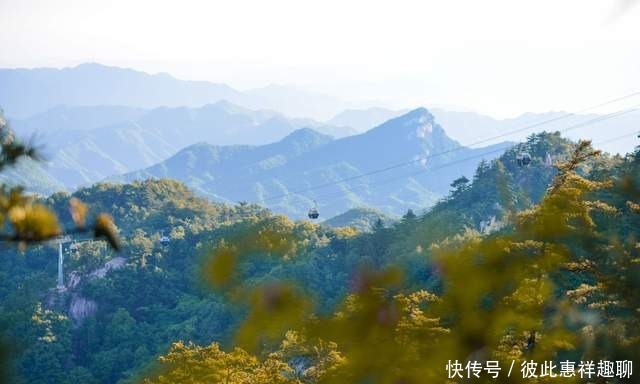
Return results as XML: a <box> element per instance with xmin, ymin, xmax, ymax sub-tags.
<box><xmin>11</xmin><ymin>101</ymin><xmax>353</xmax><ymax>189</ymax></box>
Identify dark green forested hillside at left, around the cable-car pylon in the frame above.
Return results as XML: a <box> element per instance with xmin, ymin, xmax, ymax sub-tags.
<box><xmin>0</xmin><ymin>180</ymin><xmax>351</xmax><ymax>383</ymax></box>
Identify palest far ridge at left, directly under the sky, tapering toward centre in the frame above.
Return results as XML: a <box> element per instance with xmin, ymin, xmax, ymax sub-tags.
<box><xmin>0</xmin><ymin>63</ymin><xmax>364</xmax><ymax>120</ymax></box>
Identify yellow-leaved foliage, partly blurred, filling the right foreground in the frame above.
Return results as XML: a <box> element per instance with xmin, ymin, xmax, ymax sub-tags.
<box><xmin>146</xmin><ymin>142</ymin><xmax>640</xmax><ymax>383</ymax></box>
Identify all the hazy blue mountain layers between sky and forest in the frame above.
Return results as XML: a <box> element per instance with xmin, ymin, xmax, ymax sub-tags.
<box><xmin>0</xmin><ymin>64</ymin><xmax>640</xmax><ymax>214</ymax></box>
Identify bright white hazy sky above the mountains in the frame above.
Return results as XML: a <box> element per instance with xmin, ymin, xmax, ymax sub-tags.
<box><xmin>0</xmin><ymin>0</ymin><xmax>640</xmax><ymax>117</ymax></box>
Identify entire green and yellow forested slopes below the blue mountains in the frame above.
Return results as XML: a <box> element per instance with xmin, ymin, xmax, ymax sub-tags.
<box><xmin>0</xmin><ymin>130</ymin><xmax>640</xmax><ymax>383</ymax></box>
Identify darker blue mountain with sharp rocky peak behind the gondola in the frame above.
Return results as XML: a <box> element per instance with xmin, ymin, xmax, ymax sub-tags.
<box><xmin>113</xmin><ymin>108</ymin><xmax>510</xmax><ymax>217</ymax></box>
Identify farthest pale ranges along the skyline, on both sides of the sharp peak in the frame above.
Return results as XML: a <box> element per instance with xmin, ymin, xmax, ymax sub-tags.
<box><xmin>0</xmin><ymin>63</ymin><xmax>640</xmax><ymax>153</ymax></box>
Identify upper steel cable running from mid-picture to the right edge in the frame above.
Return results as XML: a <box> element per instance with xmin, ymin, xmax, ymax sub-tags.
<box><xmin>262</xmin><ymin>91</ymin><xmax>640</xmax><ymax>202</ymax></box>
